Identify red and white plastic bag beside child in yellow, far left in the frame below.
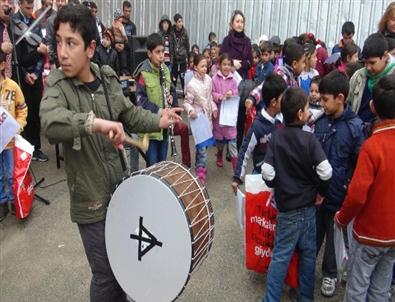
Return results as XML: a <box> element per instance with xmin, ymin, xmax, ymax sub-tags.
<box><xmin>13</xmin><ymin>135</ymin><xmax>34</xmax><ymax>220</ymax></box>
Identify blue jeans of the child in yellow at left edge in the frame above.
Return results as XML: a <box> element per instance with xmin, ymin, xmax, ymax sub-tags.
<box><xmin>0</xmin><ymin>149</ymin><xmax>14</xmax><ymax>204</ymax></box>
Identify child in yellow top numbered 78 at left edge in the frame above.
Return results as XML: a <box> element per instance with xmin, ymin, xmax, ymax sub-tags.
<box><xmin>0</xmin><ymin>51</ymin><xmax>27</xmax><ymax>220</ymax></box>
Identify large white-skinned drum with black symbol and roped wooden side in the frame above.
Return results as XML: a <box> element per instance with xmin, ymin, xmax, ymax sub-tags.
<box><xmin>105</xmin><ymin>162</ymin><xmax>214</xmax><ymax>302</ymax></box>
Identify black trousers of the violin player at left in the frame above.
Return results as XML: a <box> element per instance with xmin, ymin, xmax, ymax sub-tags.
<box><xmin>21</xmin><ymin>76</ymin><xmax>43</xmax><ymax>150</ymax></box>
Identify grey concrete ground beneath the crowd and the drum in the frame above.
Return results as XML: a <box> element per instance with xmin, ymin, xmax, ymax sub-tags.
<box><xmin>0</xmin><ymin>133</ymin><xmax>344</xmax><ymax>302</ymax></box>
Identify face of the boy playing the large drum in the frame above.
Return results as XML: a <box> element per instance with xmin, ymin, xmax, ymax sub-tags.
<box><xmin>56</xmin><ymin>23</ymin><xmax>96</xmax><ymax>79</ymax></box>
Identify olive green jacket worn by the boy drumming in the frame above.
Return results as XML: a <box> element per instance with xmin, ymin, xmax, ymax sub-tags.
<box><xmin>40</xmin><ymin>63</ymin><xmax>159</xmax><ymax>224</ymax></box>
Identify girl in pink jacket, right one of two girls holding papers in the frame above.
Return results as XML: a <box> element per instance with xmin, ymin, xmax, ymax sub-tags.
<box><xmin>212</xmin><ymin>53</ymin><xmax>238</xmax><ymax>170</ymax></box>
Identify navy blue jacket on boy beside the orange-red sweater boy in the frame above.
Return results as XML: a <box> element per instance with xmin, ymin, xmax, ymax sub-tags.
<box><xmin>315</xmin><ymin>106</ymin><xmax>365</xmax><ymax>212</ymax></box>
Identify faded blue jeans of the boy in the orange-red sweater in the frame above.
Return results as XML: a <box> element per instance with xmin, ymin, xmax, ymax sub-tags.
<box><xmin>344</xmin><ymin>240</ymin><xmax>395</xmax><ymax>302</ymax></box>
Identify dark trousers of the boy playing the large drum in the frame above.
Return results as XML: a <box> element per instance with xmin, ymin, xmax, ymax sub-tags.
<box><xmin>78</xmin><ymin>220</ymin><xmax>127</xmax><ymax>302</ymax></box>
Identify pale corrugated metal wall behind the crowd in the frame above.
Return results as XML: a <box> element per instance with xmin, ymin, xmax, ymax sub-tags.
<box><xmin>96</xmin><ymin>0</ymin><xmax>391</xmax><ymax>51</ymax></box>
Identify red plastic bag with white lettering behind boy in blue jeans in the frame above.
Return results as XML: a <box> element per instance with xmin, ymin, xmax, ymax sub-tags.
<box><xmin>245</xmin><ymin>175</ymin><xmax>299</xmax><ymax>288</ymax></box>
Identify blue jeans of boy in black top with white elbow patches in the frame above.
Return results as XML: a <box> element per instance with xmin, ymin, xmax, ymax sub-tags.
<box><xmin>263</xmin><ymin>206</ymin><xmax>317</xmax><ymax>302</ymax></box>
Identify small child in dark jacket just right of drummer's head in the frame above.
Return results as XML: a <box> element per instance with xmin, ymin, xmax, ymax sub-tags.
<box><xmin>93</xmin><ymin>29</ymin><xmax>120</xmax><ymax>75</ymax></box>
